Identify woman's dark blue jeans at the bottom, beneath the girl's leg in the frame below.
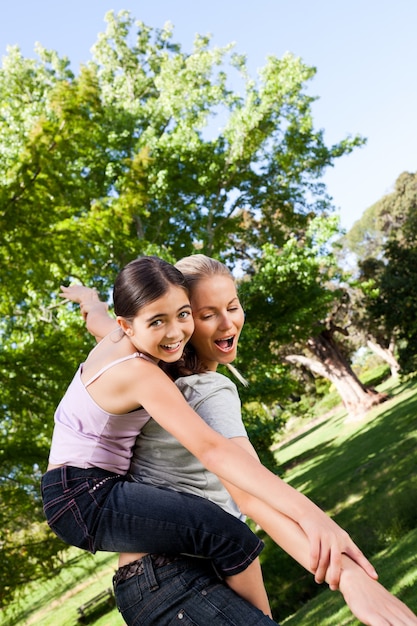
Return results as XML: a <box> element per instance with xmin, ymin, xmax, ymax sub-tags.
<box><xmin>114</xmin><ymin>556</ymin><xmax>276</xmax><ymax>626</ymax></box>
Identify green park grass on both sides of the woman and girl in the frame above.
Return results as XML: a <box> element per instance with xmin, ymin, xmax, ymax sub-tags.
<box><xmin>0</xmin><ymin>372</ymin><xmax>417</xmax><ymax>626</ymax></box>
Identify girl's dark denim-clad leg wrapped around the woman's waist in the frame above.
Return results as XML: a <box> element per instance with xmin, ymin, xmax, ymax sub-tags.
<box><xmin>95</xmin><ymin>481</ymin><xmax>263</xmax><ymax>576</ymax></box>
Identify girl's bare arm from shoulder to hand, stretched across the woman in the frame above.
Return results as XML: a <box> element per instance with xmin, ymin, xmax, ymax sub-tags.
<box><xmin>132</xmin><ymin>364</ymin><xmax>376</xmax><ymax>587</ymax></box>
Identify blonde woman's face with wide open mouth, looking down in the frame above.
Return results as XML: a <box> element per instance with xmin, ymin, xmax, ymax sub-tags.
<box><xmin>191</xmin><ymin>275</ymin><xmax>244</xmax><ymax>371</ymax></box>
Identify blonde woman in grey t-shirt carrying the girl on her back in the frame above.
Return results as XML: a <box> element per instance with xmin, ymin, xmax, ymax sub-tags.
<box><xmin>73</xmin><ymin>255</ymin><xmax>417</xmax><ymax>626</ymax></box>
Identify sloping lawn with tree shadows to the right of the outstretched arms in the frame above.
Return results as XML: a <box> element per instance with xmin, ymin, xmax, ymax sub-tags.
<box><xmin>270</xmin><ymin>372</ymin><xmax>417</xmax><ymax>626</ymax></box>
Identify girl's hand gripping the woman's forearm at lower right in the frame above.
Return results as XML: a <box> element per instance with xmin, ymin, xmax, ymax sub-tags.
<box><xmin>299</xmin><ymin>507</ymin><xmax>378</xmax><ymax>590</ymax></box>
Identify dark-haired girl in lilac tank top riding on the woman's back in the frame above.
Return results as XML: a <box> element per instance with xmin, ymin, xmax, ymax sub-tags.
<box><xmin>42</xmin><ymin>257</ymin><xmax>264</xmax><ymax>606</ymax></box>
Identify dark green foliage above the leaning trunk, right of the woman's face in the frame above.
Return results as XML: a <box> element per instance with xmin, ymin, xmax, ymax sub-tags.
<box><xmin>239</xmin><ymin>218</ymin><xmax>339</xmax><ymax>401</ymax></box>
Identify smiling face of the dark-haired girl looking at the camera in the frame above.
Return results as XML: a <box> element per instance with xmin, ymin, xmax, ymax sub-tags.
<box><xmin>119</xmin><ymin>285</ymin><xmax>194</xmax><ymax>363</ymax></box>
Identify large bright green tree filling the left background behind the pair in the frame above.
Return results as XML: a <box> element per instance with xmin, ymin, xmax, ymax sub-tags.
<box><xmin>0</xmin><ymin>12</ymin><xmax>363</xmax><ymax>603</ymax></box>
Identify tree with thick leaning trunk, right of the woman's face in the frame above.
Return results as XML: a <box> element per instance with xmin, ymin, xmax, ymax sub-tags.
<box><xmin>242</xmin><ymin>218</ymin><xmax>387</xmax><ymax>418</ymax></box>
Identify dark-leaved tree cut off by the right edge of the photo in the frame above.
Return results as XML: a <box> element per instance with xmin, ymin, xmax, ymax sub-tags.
<box><xmin>344</xmin><ymin>172</ymin><xmax>417</xmax><ymax>375</ymax></box>
